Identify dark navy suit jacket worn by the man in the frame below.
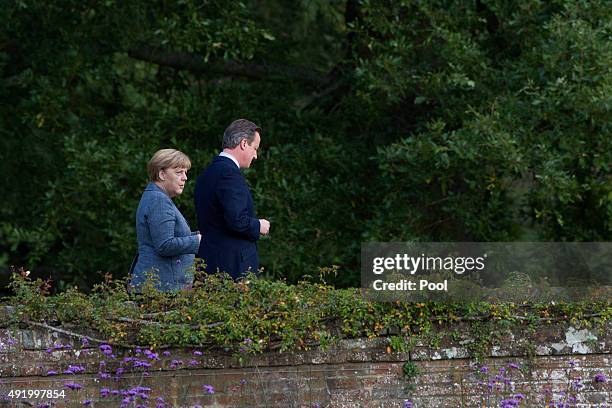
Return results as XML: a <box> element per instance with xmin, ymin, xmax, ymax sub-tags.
<box><xmin>195</xmin><ymin>156</ymin><xmax>259</xmax><ymax>279</ymax></box>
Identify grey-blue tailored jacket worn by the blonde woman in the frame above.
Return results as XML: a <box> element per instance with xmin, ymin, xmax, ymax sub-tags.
<box><xmin>131</xmin><ymin>183</ymin><xmax>198</xmax><ymax>292</ymax></box>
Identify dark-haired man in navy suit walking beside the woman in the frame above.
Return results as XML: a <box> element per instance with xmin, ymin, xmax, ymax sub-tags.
<box><xmin>195</xmin><ymin>119</ymin><xmax>270</xmax><ymax>279</ymax></box>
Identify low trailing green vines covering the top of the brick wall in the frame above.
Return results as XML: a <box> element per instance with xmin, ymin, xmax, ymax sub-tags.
<box><xmin>5</xmin><ymin>271</ymin><xmax>612</xmax><ymax>358</ymax></box>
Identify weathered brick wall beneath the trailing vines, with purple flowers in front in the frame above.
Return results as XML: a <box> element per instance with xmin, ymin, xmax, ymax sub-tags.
<box><xmin>0</xmin><ymin>323</ymin><xmax>612</xmax><ymax>408</ymax></box>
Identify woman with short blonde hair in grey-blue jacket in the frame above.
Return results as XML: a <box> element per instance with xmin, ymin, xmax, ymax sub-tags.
<box><xmin>131</xmin><ymin>149</ymin><xmax>201</xmax><ymax>292</ymax></box>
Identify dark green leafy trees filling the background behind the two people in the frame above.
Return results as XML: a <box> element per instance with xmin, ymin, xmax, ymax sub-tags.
<box><xmin>0</xmin><ymin>0</ymin><xmax>612</xmax><ymax>289</ymax></box>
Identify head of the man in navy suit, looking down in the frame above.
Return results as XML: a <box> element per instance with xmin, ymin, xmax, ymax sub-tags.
<box><xmin>223</xmin><ymin>119</ymin><xmax>261</xmax><ymax>169</ymax></box>
